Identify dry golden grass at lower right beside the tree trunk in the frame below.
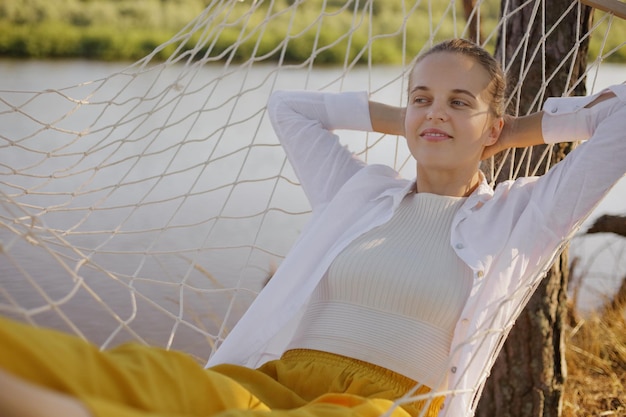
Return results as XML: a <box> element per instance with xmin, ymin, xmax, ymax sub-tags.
<box><xmin>563</xmin><ymin>277</ymin><xmax>626</xmax><ymax>417</ymax></box>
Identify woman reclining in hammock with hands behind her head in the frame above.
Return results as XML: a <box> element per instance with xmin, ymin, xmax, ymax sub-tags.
<box><xmin>0</xmin><ymin>40</ymin><xmax>626</xmax><ymax>416</ymax></box>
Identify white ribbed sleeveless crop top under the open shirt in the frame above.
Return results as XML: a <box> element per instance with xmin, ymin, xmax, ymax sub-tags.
<box><xmin>289</xmin><ymin>193</ymin><xmax>472</xmax><ymax>388</ymax></box>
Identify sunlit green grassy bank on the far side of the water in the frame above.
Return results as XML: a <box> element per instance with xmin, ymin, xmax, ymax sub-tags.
<box><xmin>0</xmin><ymin>0</ymin><xmax>626</xmax><ymax>64</ymax></box>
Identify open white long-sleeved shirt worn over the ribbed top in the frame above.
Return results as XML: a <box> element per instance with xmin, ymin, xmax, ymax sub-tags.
<box><xmin>207</xmin><ymin>85</ymin><xmax>626</xmax><ymax>417</ymax></box>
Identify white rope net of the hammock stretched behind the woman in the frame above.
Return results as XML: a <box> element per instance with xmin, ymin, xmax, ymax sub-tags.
<box><xmin>0</xmin><ymin>0</ymin><xmax>625</xmax><ymax>412</ymax></box>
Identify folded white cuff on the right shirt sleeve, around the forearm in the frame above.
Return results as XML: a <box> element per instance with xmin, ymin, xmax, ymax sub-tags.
<box><xmin>542</xmin><ymin>84</ymin><xmax>626</xmax><ymax>144</ymax></box>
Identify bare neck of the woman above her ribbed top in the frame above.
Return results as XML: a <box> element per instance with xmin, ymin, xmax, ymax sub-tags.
<box><xmin>417</xmin><ymin>167</ymin><xmax>481</xmax><ymax>197</ymax></box>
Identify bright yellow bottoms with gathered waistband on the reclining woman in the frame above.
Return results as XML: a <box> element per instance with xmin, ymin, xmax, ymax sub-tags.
<box><xmin>0</xmin><ymin>317</ymin><xmax>443</xmax><ymax>417</ymax></box>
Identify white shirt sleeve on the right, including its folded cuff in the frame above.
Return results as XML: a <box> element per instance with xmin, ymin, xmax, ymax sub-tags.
<box><xmin>532</xmin><ymin>84</ymin><xmax>626</xmax><ymax>238</ymax></box>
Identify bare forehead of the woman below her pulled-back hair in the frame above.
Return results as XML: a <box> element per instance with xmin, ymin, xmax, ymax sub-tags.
<box><xmin>409</xmin><ymin>52</ymin><xmax>491</xmax><ymax>95</ymax></box>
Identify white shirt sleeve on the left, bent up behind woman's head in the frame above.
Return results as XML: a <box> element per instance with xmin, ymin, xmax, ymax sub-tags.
<box><xmin>268</xmin><ymin>91</ymin><xmax>372</xmax><ymax>210</ymax></box>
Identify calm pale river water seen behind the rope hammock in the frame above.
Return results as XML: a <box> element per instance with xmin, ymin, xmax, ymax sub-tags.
<box><xmin>0</xmin><ymin>60</ymin><xmax>626</xmax><ymax>357</ymax></box>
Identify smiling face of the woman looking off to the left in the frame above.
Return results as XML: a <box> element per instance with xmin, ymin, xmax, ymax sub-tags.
<box><xmin>404</xmin><ymin>52</ymin><xmax>502</xmax><ymax>171</ymax></box>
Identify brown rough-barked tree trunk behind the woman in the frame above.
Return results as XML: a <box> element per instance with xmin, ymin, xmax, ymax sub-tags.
<box><xmin>476</xmin><ymin>0</ymin><xmax>592</xmax><ymax>417</ymax></box>
